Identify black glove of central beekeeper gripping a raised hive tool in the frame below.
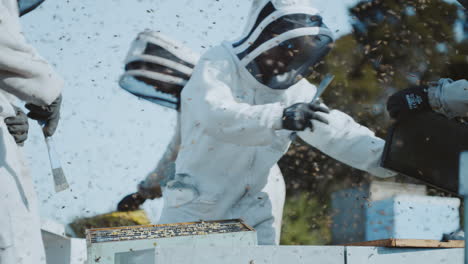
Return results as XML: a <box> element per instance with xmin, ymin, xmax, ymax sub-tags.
<box><xmin>283</xmin><ymin>102</ymin><xmax>330</xmax><ymax>131</ymax></box>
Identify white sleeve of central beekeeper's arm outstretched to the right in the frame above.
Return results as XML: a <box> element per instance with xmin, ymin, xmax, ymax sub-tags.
<box><xmin>298</xmin><ymin>110</ymin><xmax>396</xmax><ymax>178</ymax></box>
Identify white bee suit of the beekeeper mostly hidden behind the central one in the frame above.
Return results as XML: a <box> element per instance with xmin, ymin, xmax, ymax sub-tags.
<box><xmin>119</xmin><ymin>31</ymin><xmax>286</xmax><ymax>233</ymax></box>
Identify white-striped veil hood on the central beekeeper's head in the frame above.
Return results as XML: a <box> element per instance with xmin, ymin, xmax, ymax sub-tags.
<box><xmin>232</xmin><ymin>0</ymin><xmax>333</xmax><ymax>90</ymax></box>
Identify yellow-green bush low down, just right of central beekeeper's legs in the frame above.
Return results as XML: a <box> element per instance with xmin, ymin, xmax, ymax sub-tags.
<box><xmin>281</xmin><ymin>193</ymin><xmax>331</xmax><ymax>245</ymax></box>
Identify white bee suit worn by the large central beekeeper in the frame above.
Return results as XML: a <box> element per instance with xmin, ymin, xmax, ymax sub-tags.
<box><xmin>160</xmin><ymin>0</ymin><xmax>395</xmax><ymax>244</ymax></box>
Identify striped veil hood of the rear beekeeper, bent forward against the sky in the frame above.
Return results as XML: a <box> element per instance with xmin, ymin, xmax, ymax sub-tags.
<box><xmin>119</xmin><ymin>31</ymin><xmax>199</xmax><ymax>109</ymax></box>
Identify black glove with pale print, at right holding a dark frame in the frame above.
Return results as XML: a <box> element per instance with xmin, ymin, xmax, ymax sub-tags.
<box><xmin>387</xmin><ymin>86</ymin><xmax>431</xmax><ymax>119</ymax></box>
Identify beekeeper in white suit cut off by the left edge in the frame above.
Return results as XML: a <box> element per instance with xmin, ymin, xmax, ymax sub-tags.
<box><xmin>0</xmin><ymin>0</ymin><xmax>63</xmax><ymax>264</ymax></box>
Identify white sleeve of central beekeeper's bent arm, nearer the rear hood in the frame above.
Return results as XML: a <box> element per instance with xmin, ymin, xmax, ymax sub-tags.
<box><xmin>182</xmin><ymin>50</ymin><xmax>283</xmax><ymax>146</ymax></box>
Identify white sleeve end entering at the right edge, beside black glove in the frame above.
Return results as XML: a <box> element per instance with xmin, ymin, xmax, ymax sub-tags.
<box><xmin>428</xmin><ymin>79</ymin><xmax>468</xmax><ymax>118</ymax></box>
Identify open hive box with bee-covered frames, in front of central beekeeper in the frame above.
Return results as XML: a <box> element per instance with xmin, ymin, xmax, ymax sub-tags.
<box><xmin>86</xmin><ymin>220</ymin><xmax>257</xmax><ymax>264</ymax></box>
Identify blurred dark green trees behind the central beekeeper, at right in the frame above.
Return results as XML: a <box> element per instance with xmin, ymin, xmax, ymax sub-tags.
<box><xmin>279</xmin><ymin>0</ymin><xmax>468</xmax><ymax>245</ymax></box>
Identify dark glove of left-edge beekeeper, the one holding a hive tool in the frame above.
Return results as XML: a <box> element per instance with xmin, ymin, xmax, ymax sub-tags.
<box><xmin>26</xmin><ymin>95</ymin><xmax>62</xmax><ymax>137</ymax></box>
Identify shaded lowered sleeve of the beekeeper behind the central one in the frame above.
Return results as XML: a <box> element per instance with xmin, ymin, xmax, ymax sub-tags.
<box><xmin>138</xmin><ymin>116</ymin><xmax>181</xmax><ymax>197</ymax></box>
